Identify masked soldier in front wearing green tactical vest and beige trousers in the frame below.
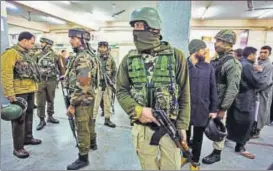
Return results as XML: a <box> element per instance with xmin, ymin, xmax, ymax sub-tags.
<box><xmin>116</xmin><ymin>7</ymin><xmax>190</xmax><ymax>170</ymax></box>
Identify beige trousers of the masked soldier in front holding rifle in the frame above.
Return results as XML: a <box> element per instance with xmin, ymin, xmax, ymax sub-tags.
<box><xmin>132</xmin><ymin>124</ymin><xmax>181</xmax><ymax>170</ymax></box>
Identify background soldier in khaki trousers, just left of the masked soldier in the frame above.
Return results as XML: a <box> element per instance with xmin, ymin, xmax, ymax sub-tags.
<box><xmin>94</xmin><ymin>42</ymin><xmax>117</xmax><ymax>128</ymax></box>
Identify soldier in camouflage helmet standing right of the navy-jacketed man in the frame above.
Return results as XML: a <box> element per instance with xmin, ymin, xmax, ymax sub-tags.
<box><xmin>202</xmin><ymin>30</ymin><xmax>242</xmax><ymax>164</ymax></box>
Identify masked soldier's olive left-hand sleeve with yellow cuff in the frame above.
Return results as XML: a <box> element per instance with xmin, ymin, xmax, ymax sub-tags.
<box><xmin>116</xmin><ymin>55</ymin><xmax>143</xmax><ymax>120</ymax></box>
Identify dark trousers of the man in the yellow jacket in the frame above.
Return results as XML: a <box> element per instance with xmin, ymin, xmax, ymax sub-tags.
<box><xmin>11</xmin><ymin>93</ymin><xmax>34</xmax><ymax>150</ymax></box>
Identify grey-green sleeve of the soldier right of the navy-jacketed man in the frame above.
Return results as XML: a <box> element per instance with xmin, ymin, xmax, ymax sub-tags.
<box><xmin>220</xmin><ymin>60</ymin><xmax>242</xmax><ymax>111</ymax></box>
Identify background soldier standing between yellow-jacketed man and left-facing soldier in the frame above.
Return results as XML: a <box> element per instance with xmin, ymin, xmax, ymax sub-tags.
<box><xmin>35</xmin><ymin>38</ymin><xmax>65</xmax><ymax>130</ymax></box>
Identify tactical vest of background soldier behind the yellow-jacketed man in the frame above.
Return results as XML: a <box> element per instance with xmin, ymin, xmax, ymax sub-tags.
<box><xmin>38</xmin><ymin>50</ymin><xmax>59</xmax><ymax>80</ymax></box>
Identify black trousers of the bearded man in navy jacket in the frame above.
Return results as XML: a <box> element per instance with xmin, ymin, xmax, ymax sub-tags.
<box><xmin>184</xmin><ymin>125</ymin><xmax>206</xmax><ymax>163</ymax></box>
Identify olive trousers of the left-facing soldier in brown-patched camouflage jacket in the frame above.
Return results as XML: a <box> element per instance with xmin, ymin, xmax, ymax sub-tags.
<box><xmin>75</xmin><ymin>103</ymin><xmax>94</xmax><ymax>155</ymax></box>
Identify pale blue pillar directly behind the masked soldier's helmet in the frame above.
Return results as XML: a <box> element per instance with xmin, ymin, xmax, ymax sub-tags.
<box><xmin>157</xmin><ymin>1</ymin><xmax>191</xmax><ymax>56</ymax></box>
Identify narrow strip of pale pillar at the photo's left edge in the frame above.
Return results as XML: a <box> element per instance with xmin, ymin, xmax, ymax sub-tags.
<box><xmin>0</xmin><ymin>1</ymin><xmax>9</xmax><ymax>105</ymax></box>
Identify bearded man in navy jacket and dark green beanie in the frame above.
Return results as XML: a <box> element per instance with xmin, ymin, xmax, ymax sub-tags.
<box><xmin>182</xmin><ymin>39</ymin><xmax>217</xmax><ymax>170</ymax></box>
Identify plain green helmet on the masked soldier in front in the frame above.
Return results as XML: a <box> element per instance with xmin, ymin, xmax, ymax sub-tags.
<box><xmin>130</xmin><ymin>7</ymin><xmax>161</xmax><ymax>30</ymax></box>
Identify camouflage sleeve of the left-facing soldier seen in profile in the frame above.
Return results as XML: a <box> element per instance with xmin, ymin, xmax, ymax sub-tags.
<box><xmin>70</xmin><ymin>54</ymin><xmax>94</xmax><ymax>106</ymax></box>
